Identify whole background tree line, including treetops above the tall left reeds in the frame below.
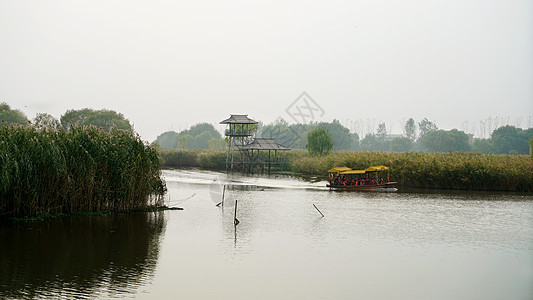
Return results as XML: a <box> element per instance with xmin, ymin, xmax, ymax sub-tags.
<box><xmin>0</xmin><ymin>102</ymin><xmax>533</xmax><ymax>155</ymax></box>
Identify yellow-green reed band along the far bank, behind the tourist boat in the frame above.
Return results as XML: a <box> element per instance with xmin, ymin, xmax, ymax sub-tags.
<box><xmin>161</xmin><ymin>150</ymin><xmax>533</xmax><ymax>192</ymax></box>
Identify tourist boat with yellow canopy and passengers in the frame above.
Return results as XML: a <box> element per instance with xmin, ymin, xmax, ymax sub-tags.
<box><xmin>326</xmin><ymin>166</ymin><xmax>397</xmax><ymax>191</ymax></box>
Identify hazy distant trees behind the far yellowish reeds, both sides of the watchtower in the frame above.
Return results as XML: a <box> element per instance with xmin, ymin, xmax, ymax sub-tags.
<box><xmin>156</xmin><ymin>118</ymin><xmax>533</xmax><ymax>154</ymax></box>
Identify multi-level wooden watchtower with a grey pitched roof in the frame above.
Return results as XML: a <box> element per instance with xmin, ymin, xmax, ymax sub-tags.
<box><xmin>220</xmin><ymin>115</ymin><xmax>257</xmax><ymax>170</ymax></box>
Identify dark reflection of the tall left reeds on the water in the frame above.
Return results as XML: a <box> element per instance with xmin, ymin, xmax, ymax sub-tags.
<box><xmin>0</xmin><ymin>212</ymin><xmax>166</xmax><ymax>299</ymax></box>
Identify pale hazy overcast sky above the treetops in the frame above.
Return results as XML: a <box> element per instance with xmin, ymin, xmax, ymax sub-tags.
<box><xmin>0</xmin><ymin>0</ymin><xmax>533</xmax><ymax>141</ymax></box>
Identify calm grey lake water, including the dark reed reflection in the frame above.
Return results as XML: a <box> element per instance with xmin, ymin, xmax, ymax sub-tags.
<box><xmin>0</xmin><ymin>170</ymin><xmax>533</xmax><ymax>299</ymax></box>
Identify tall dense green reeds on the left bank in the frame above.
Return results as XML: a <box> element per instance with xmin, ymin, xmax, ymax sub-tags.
<box><xmin>0</xmin><ymin>125</ymin><xmax>166</xmax><ymax>216</ymax></box>
